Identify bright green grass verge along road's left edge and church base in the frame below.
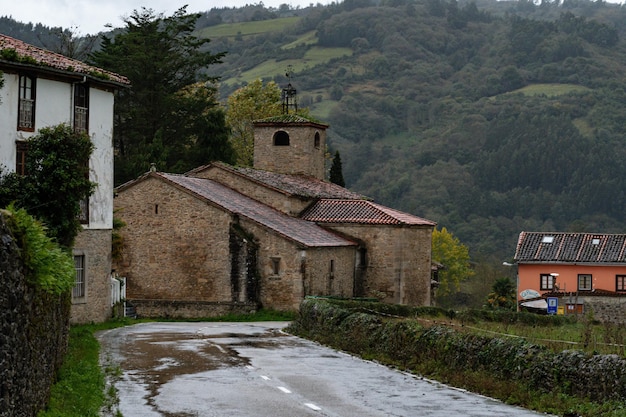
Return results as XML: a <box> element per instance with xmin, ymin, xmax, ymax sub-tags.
<box><xmin>37</xmin><ymin>310</ymin><xmax>296</xmax><ymax>417</ymax></box>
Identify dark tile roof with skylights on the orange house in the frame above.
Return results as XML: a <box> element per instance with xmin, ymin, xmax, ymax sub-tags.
<box><xmin>515</xmin><ymin>232</ymin><xmax>626</xmax><ymax>263</ymax></box>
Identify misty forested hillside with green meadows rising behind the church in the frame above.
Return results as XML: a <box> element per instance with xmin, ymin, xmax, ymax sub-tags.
<box><xmin>0</xmin><ymin>0</ymin><xmax>626</xmax><ymax>265</ymax></box>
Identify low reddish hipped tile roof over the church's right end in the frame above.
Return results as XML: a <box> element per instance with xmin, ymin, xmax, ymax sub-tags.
<box><xmin>301</xmin><ymin>199</ymin><xmax>436</xmax><ymax>226</ymax></box>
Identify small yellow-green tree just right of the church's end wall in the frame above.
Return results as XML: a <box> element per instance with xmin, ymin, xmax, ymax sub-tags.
<box><xmin>432</xmin><ymin>227</ymin><xmax>474</xmax><ymax>296</ymax></box>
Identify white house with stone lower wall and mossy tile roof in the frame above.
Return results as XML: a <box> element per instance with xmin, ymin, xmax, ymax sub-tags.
<box><xmin>0</xmin><ymin>34</ymin><xmax>129</xmax><ymax>323</ymax></box>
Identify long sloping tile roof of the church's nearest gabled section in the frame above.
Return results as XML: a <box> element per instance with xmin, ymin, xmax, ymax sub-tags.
<box><xmin>158</xmin><ymin>172</ymin><xmax>356</xmax><ymax>247</ymax></box>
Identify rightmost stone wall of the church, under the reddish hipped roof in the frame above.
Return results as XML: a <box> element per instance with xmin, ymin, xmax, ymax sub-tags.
<box><xmin>325</xmin><ymin>224</ymin><xmax>432</xmax><ymax>306</ymax></box>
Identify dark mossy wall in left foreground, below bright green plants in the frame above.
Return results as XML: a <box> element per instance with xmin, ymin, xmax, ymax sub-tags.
<box><xmin>0</xmin><ymin>213</ymin><xmax>70</xmax><ymax>417</ymax></box>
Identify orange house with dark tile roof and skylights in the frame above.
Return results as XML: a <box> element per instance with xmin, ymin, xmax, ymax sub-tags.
<box><xmin>514</xmin><ymin>232</ymin><xmax>626</xmax><ymax>312</ymax></box>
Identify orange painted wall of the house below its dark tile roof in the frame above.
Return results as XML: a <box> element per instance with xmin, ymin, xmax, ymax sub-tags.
<box><xmin>517</xmin><ymin>264</ymin><xmax>626</xmax><ymax>300</ymax></box>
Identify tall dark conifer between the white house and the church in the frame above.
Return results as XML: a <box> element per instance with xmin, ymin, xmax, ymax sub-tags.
<box><xmin>91</xmin><ymin>6</ymin><xmax>232</xmax><ymax>184</ymax></box>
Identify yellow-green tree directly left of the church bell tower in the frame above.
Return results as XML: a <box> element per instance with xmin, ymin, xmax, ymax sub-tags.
<box><xmin>226</xmin><ymin>79</ymin><xmax>282</xmax><ymax>166</ymax></box>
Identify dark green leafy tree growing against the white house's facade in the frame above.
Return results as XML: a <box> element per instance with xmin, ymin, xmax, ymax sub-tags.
<box><xmin>0</xmin><ymin>124</ymin><xmax>96</xmax><ymax>248</ymax></box>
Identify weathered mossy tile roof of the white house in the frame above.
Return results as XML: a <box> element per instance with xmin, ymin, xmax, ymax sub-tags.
<box><xmin>0</xmin><ymin>34</ymin><xmax>130</xmax><ymax>86</ymax></box>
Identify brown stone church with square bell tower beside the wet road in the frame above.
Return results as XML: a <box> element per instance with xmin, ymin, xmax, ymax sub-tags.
<box><xmin>114</xmin><ymin>114</ymin><xmax>435</xmax><ymax>318</ymax></box>
